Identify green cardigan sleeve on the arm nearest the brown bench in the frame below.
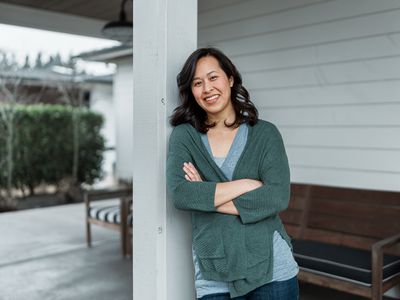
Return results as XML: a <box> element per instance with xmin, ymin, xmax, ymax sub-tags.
<box><xmin>234</xmin><ymin>125</ymin><xmax>290</xmax><ymax>224</ymax></box>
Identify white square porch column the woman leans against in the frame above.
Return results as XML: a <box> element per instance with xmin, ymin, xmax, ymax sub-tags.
<box><xmin>132</xmin><ymin>0</ymin><xmax>197</xmax><ymax>300</ymax></box>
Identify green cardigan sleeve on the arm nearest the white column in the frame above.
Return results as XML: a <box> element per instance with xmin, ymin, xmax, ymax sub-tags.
<box><xmin>166</xmin><ymin>127</ymin><xmax>217</xmax><ymax>212</ymax></box>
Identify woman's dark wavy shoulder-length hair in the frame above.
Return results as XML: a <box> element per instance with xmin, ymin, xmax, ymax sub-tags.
<box><xmin>170</xmin><ymin>48</ymin><xmax>258</xmax><ymax>133</ymax></box>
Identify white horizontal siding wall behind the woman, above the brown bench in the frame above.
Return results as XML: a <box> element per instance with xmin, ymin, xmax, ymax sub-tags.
<box><xmin>198</xmin><ymin>0</ymin><xmax>400</xmax><ymax>191</ymax></box>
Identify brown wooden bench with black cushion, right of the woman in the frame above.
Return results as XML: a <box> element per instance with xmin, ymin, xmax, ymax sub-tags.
<box><xmin>281</xmin><ymin>184</ymin><xmax>400</xmax><ymax>300</ymax></box>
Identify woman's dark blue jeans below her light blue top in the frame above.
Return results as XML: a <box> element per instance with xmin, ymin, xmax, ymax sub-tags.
<box><xmin>199</xmin><ymin>277</ymin><xmax>299</xmax><ymax>300</ymax></box>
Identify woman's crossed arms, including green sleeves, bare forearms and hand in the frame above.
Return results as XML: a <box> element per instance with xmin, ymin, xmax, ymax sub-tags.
<box><xmin>166</xmin><ymin>123</ymin><xmax>290</xmax><ymax>224</ymax></box>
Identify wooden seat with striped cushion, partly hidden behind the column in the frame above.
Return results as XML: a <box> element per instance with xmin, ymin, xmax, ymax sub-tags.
<box><xmin>84</xmin><ymin>186</ymin><xmax>132</xmax><ymax>256</ymax></box>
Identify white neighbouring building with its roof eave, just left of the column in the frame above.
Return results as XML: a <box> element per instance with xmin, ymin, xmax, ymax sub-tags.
<box><xmin>75</xmin><ymin>44</ymin><xmax>133</xmax><ymax>181</ymax></box>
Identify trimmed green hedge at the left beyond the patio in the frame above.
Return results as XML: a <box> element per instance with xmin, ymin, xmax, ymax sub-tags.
<box><xmin>0</xmin><ymin>105</ymin><xmax>105</xmax><ymax>191</ymax></box>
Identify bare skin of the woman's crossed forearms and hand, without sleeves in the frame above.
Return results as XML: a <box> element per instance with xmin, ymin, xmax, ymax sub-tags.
<box><xmin>183</xmin><ymin>162</ymin><xmax>263</xmax><ymax>216</ymax></box>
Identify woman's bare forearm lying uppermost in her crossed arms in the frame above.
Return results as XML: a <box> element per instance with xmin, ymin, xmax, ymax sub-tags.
<box><xmin>214</xmin><ymin>179</ymin><xmax>262</xmax><ymax>207</ymax></box>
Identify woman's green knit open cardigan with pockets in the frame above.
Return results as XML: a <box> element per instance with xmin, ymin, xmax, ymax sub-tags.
<box><xmin>166</xmin><ymin>120</ymin><xmax>290</xmax><ymax>297</ymax></box>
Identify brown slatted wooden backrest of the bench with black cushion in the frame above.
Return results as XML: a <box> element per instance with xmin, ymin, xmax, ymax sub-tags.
<box><xmin>281</xmin><ymin>184</ymin><xmax>400</xmax><ymax>253</ymax></box>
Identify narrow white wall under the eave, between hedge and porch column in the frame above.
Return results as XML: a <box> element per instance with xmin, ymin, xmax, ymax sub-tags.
<box><xmin>113</xmin><ymin>57</ymin><xmax>133</xmax><ymax>181</ymax></box>
